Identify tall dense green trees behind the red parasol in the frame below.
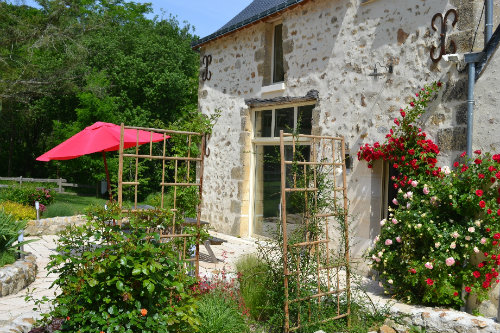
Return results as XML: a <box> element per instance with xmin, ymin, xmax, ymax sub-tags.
<box><xmin>0</xmin><ymin>0</ymin><xmax>199</xmax><ymax>183</ymax></box>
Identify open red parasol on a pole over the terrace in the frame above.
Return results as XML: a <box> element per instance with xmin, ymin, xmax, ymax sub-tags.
<box><xmin>36</xmin><ymin>121</ymin><xmax>169</xmax><ymax>199</ymax></box>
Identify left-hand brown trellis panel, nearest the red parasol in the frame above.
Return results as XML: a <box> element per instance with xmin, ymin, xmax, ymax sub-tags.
<box><xmin>118</xmin><ymin>124</ymin><xmax>207</xmax><ymax>276</ymax></box>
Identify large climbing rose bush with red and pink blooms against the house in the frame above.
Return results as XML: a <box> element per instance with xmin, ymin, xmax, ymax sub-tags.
<box><xmin>358</xmin><ymin>82</ymin><xmax>500</xmax><ymax>307</ymax></box>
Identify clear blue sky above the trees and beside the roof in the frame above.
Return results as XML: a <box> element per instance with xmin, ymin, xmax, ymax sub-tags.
<box><xmin>10</xmin><ymin>0</ymin><xmax>252</xmax><ymax>37</ymax></box>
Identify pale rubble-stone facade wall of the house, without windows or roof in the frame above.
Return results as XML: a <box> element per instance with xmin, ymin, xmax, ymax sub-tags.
<box><xmin>199</xmin><ymin>0</ymin><xmax>499</xmax><ymax>257</ymax></box>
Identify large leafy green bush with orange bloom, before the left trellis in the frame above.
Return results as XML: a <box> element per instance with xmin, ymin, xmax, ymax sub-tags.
<box><xmin>39</xmin><ymin>206</ymin><xmax>199</xmax><ymax>332</ymax></box>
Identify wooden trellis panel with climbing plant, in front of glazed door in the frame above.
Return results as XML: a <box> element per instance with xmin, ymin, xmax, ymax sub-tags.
<box><xmin>280</xmin><ymin>131</ymin><xmax>351</xmax><ymax>333</ymax></box>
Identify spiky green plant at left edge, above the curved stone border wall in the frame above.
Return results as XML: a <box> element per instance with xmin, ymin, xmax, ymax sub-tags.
<box><xmin>0</xmin><ymin>210</ymin><xmax>35</xmax><ymax>266</ymax></box>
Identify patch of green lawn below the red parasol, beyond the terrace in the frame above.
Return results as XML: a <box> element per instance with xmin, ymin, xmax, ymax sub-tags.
<box><xmin>43</xmin><ymin>193</ymin><xmax>107</xmax><ymax>218</ymax></box>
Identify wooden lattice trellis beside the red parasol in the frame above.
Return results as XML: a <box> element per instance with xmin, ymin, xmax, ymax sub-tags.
<box><xmin>118</xmin><ymin>124</ymin><xmax>206</xmax><ymax>276</ymax></box>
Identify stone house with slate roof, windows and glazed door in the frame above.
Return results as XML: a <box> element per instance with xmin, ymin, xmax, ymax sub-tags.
<box><xmin>193</xmin><ymin>0</ymin><xmax>500</xmax><ymax>266</ymax></box>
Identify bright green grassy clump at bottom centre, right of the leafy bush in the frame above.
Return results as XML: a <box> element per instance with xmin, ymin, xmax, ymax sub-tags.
<box><xmin>198</xmin><ymin>289</ymin><xmax>249</xmax><ymax>333</ymax></box>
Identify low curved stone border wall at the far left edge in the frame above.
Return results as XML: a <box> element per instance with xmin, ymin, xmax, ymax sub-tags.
<box><xmin>0</xmin><ymin>254</ymin><xmax>38</xmax><ymax>297</ymax></box>
